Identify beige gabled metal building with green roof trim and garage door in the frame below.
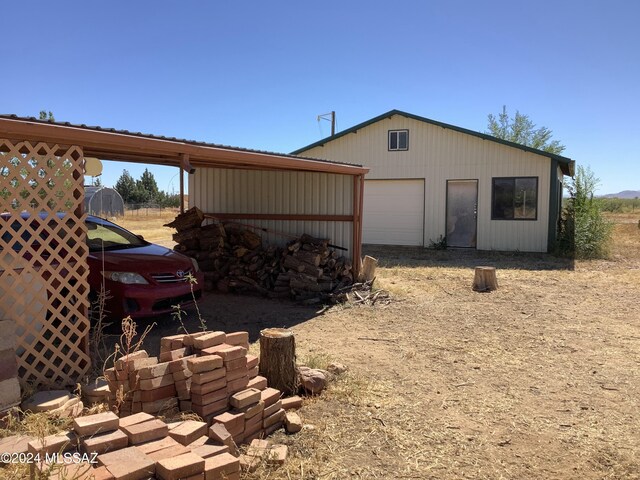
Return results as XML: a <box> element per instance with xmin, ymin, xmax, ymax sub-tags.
<box><xmin>293</xmin><ymin>110</ymin><xmax>574</xmax><ymax>252</ymax></box>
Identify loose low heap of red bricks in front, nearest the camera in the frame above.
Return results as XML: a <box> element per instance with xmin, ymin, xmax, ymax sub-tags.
<box><xmin>28</xmin><ymin>412</ymin><xmax>245</xmax><ymax>480</ymax></box>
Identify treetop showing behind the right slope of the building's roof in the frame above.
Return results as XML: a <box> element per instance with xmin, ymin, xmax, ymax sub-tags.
<box><xmin>486</xmin><ymin>106</ymin><xmax>566</xmax><ymax>154</ymax></box>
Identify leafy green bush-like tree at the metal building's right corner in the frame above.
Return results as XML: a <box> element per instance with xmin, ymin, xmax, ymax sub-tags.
<box><xmin>558</xmin><ymin>166</ymin><xmax>613</xmax><ymax>258</ymax></box>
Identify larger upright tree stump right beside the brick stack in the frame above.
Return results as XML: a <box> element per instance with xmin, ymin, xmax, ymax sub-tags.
<box><xmin>259</xmin><ymin>328</ymin><xmax>298</xmax><ymax>396</ymax></box>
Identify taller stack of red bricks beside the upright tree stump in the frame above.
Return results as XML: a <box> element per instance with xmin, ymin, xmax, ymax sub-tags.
<box><xmin>106</xmin><ymin>331</ymin><xmax>300</xmax><ymax>444</ymax></box>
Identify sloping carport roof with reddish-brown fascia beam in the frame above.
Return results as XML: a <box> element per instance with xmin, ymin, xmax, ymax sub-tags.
<box><xmin>0</xmin><ymin>115</ymin><xmax>369</xmax><ymax>175</ymax></box>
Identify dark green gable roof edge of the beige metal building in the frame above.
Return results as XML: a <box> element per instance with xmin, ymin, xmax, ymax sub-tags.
<box><xmin>291</xmin><ymin>110</ymin><xmax>575</xmax><ymax>176</ymax></box>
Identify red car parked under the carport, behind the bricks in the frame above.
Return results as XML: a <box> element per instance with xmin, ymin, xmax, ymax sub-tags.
<box><xmin>86</xmin><ymin>215</ymin><xmax>204</xmax><ymax>318</ymax></box>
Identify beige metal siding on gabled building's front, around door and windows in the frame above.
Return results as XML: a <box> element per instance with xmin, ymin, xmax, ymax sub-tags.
<box><xmin>302</xmin><ymin>115</ymin><xmax>551</xmax><ymax>252</ymax></box>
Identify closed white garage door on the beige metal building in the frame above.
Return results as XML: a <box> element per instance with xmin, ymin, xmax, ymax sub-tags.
<box><xmin>362</xmin><ymin>180</ymin><xmax>424</xmax><ymax>246</ymax></box>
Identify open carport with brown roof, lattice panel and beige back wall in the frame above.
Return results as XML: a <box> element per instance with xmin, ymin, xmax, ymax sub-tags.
<box><xmin>0</xmin><ymin>115</ymin><xmax>368</xmax><ymax>384</ymax></box>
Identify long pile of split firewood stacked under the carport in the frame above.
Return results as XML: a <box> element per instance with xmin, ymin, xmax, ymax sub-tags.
<box><xmin>165</xmin><ymin>207</ymin><xmax>354</xmax><ymax>303</ymax></box>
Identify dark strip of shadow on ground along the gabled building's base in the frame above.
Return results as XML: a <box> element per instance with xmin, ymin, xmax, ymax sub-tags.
<box><xmin>363</xmin><ymin>245</ymin><xmax>574</xmax><ymax>270</ymax></box>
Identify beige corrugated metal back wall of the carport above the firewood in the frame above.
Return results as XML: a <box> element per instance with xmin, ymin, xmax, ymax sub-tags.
<box><xmin>189</xmin><ymin>168</ymin><xmax>353</xmax><ymax>257</ymax></box>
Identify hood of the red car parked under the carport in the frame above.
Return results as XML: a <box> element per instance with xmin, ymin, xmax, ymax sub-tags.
<box><xmin>89</xmin><ymin>244</ymin><xmax>193</xmax><ymax>273</ymax></box>
